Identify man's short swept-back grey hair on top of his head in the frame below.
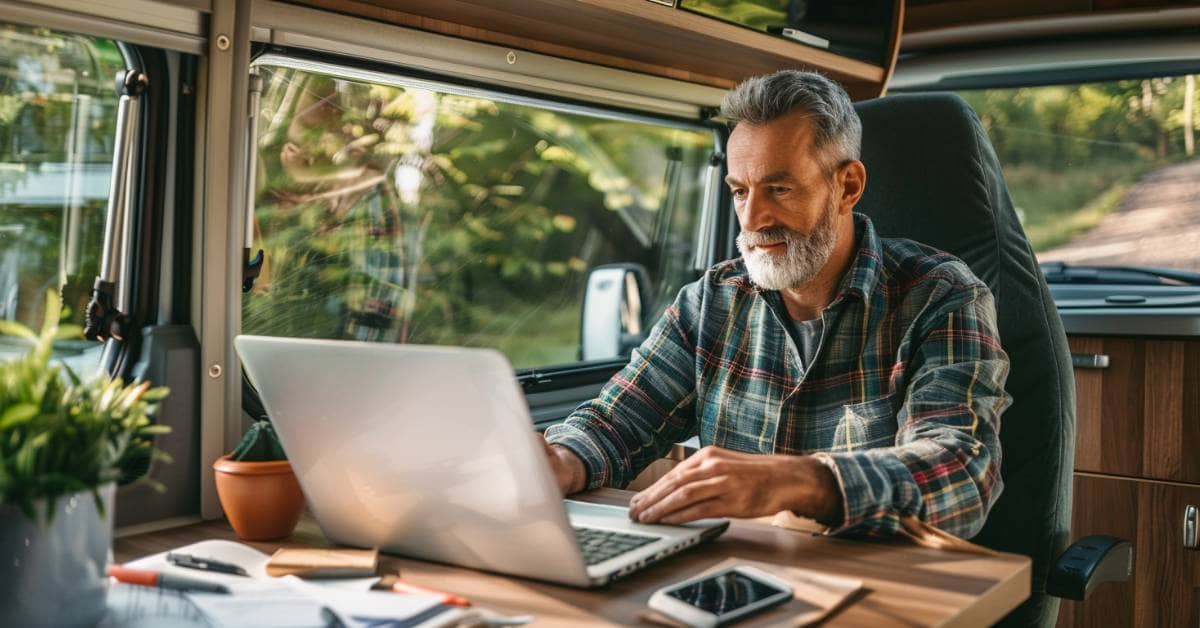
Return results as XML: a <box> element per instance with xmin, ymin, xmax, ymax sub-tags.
<box><xmin>721</xmin><ymin>70</ymin><xmax>863</xmax><ymax>171</ymax></box>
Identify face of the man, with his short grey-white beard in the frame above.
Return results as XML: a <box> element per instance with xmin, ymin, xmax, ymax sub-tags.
<box><xmin>725</xmin><ymin>114</ymin><xmax>848</xmax><ymax>291</ymax></box>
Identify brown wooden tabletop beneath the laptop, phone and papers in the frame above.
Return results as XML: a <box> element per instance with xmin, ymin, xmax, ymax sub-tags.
<box><xmin>113</xmin><ymin>489</ymin><xmax>1031</xmax><ymax>628</ymax></box>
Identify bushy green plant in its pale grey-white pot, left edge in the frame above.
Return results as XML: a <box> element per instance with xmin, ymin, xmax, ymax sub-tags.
<box><xmin>0</xmin><ymin>292</ymin><xmax>170</xmax><ymax>627</ymax></box>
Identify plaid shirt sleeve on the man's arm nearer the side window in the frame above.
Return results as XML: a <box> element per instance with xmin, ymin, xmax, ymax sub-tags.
<box><xmin>546</xmin><ymin>282</ymin><xmax>701</xmax><ymax>489</ymax></box>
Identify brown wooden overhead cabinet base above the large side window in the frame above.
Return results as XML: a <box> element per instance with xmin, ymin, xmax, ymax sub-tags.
<box><xmin>289</xmin><ymin>0</ymin><xmax>904</xmax><ymax>100</ymax></box>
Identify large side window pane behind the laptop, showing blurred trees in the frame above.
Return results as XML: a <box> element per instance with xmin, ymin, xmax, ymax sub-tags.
<box><xmin>242</xmin><ymin>61</ymin><xmax>715</xmax><ymax>369</ymax></box>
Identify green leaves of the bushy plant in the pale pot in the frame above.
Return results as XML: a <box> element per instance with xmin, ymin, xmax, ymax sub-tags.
<box><xmin>0</xmin><ymin>292</ymin><xmax>170</xmax><ymax>524</ymax></box>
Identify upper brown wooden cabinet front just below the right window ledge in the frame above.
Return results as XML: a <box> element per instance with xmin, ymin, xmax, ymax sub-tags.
<box><xmin>1068</xmin><ymin>336</ymin><xmax>1200</xmax><ymax>483</ymax></box>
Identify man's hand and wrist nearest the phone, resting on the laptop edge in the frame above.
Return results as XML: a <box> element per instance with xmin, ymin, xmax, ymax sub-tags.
<box><xmin>629</xmin><ymin>447</ymin><xmax>841</xmax><ymax>525</ymax></box>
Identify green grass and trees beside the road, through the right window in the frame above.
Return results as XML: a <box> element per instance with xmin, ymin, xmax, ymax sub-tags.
<box><xmin>961</xmin><ymin>77</ymin><xmax>1200</xmax><ymax>251</ymax></box>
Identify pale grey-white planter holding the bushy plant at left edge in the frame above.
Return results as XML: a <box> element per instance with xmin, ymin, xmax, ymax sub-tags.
<box><xmin>0</xmin><ymin>484</ymin><xmax>116</xmax><ymax>628</ymax></box>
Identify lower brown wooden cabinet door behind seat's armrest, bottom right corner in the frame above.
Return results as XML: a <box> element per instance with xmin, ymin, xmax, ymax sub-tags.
<box><xmin>1058</xmin><ymin>474</ymin><xmax>1200</xmax><ymax>627</ymax></box>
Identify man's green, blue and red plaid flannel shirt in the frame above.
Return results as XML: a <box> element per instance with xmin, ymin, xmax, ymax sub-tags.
<box><xmin>546</xmin><ymin>214</ymin><xmax>1010</xmax><ymax>538</ymax></box>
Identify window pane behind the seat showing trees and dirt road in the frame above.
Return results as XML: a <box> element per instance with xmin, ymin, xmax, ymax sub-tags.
<box><xmin>962</xmin><ymin>76</ymin><xmax>1200</xmax><ymax>270</ymax></box>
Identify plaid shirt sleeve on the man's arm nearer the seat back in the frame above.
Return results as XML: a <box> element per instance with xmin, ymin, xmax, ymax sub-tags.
<box><xmin>815</xmin><ymin>283</ymin><xmax>1012</xmax><ymax>538</ymax></box>
